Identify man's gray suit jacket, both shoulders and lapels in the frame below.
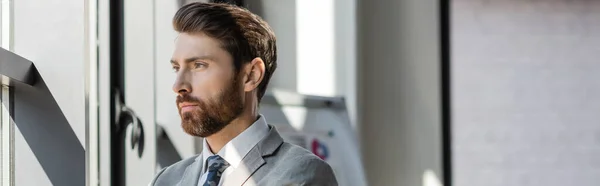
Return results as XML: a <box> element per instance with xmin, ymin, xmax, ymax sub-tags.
<box><xmin>150</xmin><ymin>125</ymin><xmax>337</xmax><ymax>186</ymax></box>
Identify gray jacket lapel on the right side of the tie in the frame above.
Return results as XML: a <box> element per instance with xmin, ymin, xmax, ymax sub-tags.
<box><xmin>223</xmin><ymin>125</ymin><xmax>283</xmax><ymax>186</ymax></box>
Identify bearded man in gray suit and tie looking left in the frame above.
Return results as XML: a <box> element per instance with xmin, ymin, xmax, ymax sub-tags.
<box><xmin>151</xmin><ymin>3</ymin><xmax>337</xmax><ymax>186</ymax></box>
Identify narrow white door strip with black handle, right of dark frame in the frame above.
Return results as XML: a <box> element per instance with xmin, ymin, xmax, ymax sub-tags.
<box><xmin>117</xmin><ymin>0</ymin><xmax>156</xmax><ymax>186</ymax></box>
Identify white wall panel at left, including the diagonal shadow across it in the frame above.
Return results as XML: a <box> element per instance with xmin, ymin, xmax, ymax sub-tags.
<box><xmin>11</xmin><ymin>0</ymin><xmax>85</xmax><ymax>186</ymax></box>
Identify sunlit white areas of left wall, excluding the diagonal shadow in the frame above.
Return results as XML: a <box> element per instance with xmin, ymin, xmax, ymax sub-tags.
<box><xmin>11</xmin><ymin>0</ymin><xmax>86</xmax><ymax>186</ymax></box>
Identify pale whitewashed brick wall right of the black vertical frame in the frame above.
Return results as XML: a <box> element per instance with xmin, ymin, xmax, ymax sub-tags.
<box><xmin>452</xmin><ymin>0</ymin><xmax>600</xmax><ymax>186</ymax></box>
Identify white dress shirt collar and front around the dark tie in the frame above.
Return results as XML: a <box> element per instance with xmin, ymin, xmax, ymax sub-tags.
<box><xmin>198</xmin><ymin>115</ymin><xmax>269</xmax><ymax>186</ymax></box>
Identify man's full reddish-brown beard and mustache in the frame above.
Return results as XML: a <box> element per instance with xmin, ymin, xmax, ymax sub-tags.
<box><xmin>176</xmin><ymin>77</ymin><xmax>244</xmax><ymax>138</ymax></box>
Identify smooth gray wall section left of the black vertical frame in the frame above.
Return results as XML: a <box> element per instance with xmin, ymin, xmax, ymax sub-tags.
<box><xmin>357</xmin><ymin>0</ymin><xmax>442</xmax><ymax>186</ymax></box>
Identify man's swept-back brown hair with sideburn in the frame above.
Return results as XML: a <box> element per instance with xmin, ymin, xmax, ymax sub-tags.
<box><xmin>173</xmin><ymin>2</ymin><xmax>277</xmax><ymax>101</ymax></box>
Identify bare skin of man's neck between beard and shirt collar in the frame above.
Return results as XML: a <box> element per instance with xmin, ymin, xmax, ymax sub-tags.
<box><xmin>206</xmin><ymin>114</ymin><xmax>258</xmax><ymax>154</ymax></box>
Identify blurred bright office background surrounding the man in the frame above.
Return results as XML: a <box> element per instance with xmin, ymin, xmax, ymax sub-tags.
<box><xmin>0</xmin><ymin>0</ymin><xmax>600</xmax><ymax>186</ymax></box>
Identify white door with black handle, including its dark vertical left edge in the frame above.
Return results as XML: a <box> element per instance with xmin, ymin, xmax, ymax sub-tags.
<box><xmin>106</xmin><ymin>0</ymin><xmax>156</xmax><ymax>186</ymax></box>
